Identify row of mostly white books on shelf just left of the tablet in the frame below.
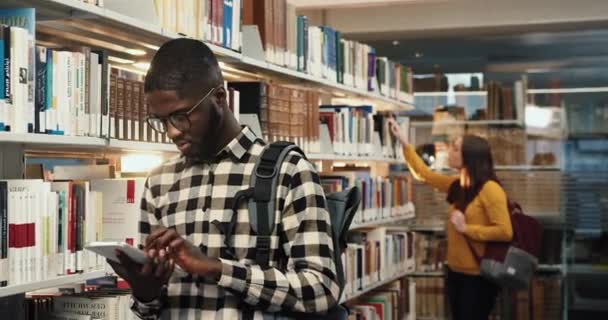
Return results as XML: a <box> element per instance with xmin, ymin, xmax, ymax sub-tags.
<box><xmin>0</xmin><ymin>179</ymin><xmax>144</xmax><ymax>286</ymax></box>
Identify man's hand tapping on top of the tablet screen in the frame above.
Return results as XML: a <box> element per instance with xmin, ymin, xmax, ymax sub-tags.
<box><xmin>145</xmin><ymin>228</ymin><xmax>222</xmax><ymax>277</ymax></box>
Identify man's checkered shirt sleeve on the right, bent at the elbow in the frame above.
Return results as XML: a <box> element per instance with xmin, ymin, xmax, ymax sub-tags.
<box><xmin>218</xmin><ymin>156</ymin><xmax>340</xmax><ymax>312</ymax></box>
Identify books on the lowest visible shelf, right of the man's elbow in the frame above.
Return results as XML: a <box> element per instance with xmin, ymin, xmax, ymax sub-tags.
<box><xmin>348</xmin><ymin>277</ymin><xmax>415</xmax><ymax>320</ymax></box>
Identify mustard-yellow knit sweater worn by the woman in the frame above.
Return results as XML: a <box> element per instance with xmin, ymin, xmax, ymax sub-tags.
<box><xmin>403</xmin><ymin>145</ymin><xmax>513</xmax><ymax>275</ymax></box>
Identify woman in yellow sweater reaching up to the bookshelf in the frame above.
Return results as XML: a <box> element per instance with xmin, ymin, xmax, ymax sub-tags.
<box><xmin>390</xmin><ymin>121</ymin><xmax>513</xmax><ymax>320</ymax></box>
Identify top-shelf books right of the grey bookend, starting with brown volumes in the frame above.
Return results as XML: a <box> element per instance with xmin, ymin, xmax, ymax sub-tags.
<box><xmin>249</xmin><ymin>0</ymin><xmax>413</xmax><ymax>101</ymax></box>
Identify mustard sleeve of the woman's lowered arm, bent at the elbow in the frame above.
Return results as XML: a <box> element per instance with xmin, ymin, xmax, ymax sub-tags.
<box><xmin>465</xmin><ymin>181</ymin><xmax>513</xmax><ymax>241</ymax></box>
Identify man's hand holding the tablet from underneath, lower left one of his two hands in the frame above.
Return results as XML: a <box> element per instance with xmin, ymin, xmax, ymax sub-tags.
<box><xmin>106</xmin><ymin>250</ymin><xmax>175</xmax><ymax>302</ymax></box>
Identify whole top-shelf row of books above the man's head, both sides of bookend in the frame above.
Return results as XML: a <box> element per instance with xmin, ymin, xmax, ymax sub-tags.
<box><xmin>148</xmin><ymin>0</ymin><xmax>413</xmax><ymax>101</ymax></box>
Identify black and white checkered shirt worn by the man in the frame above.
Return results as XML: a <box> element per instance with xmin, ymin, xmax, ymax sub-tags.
<box><xmin>133</xmin><ymin>127</ymin><xmax>339</xmax><ymax>320</ymax></box>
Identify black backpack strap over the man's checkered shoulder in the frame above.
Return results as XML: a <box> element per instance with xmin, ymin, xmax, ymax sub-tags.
<box><xmin>248</xmin><ymin>141</ymin><xmax>306</xmax><ymax>268</ymax></box>
